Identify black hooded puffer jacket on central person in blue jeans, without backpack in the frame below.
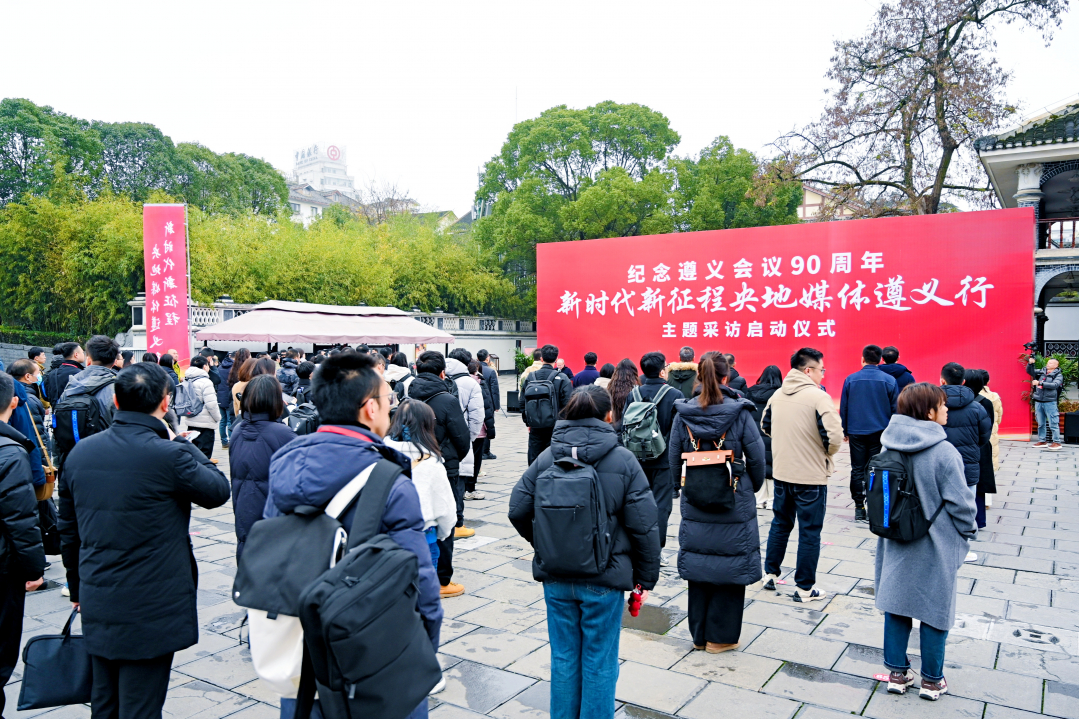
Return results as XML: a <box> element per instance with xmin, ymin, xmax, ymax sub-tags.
<box><xmin>509</xmin><ymin>419</ymin><xmax>660</xmax><ymax>592</ymax></box>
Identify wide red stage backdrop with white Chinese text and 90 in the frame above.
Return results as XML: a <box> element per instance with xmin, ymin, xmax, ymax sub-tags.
<box><xmin>536</xmin><ymin>208</ymin><xmax>1034</xmax><ymax>434</ymax></box>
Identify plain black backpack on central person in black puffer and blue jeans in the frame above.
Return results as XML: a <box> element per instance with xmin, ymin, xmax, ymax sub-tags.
<box><xmin>532</xmin><ymin>457</ymin><xmax>614</xmax><ymax>576</ymax></box>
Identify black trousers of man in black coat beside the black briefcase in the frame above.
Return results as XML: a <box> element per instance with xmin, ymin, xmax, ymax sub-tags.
<box><xmin>90</xmin><ymin>653</ymin><xmax>173</xmax><ymax>719</ymax></box>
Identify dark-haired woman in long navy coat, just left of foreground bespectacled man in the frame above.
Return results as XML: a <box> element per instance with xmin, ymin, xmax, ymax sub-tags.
<box><xmin>229</xmin><ymin>375</ymin><xmax>296</xmax><ymax>560</ymax></box>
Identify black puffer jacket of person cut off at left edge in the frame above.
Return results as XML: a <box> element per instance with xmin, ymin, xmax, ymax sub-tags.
<box><xmin>0</xmin><ymin>422</ymin><xmax>45</xmax><ymax>582</ymax></box>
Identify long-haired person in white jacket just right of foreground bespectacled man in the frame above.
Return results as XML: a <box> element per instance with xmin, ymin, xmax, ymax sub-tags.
<box><xmin>384</xmin><ymin>399</ymin><xmax>457</xmax><ymax>567</ymax></box>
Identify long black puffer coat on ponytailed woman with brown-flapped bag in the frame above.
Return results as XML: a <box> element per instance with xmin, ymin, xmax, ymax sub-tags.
<box><xmin>670</xmin><ymin>397</ymin><xmax>764</xmax><ymax>586</ymax></box>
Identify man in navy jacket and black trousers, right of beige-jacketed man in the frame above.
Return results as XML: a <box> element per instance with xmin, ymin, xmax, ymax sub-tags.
<box><xmin>839</xmin><ymin>344</ymin><xmax>899</xmax><ymax>521</ymax></box>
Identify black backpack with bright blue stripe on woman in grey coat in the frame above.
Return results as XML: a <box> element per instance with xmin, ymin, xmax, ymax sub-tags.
<box><xmin>865</xmin><ymin>449</ymin><xmax>944</xmax><ymax>542</ymax></box>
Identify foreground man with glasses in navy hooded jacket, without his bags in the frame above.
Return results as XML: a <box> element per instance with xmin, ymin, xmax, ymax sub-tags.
<box><xmin>263</xmin><ymin>351</ymin><xmax>442</xmax><ymax>717</ymax></box>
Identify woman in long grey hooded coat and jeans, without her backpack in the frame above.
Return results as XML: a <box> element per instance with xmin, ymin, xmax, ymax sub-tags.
<box><xmin>870</xmin><ymin>382</ymin><xmax>974</xmax><ymax>701</ymax></box>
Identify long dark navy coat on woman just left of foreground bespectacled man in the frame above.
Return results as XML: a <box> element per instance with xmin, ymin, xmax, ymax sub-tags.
<box><xmin>229</xmin><ymin>415</ymin><xmax>296</xmax><ymax>561</ymax></box>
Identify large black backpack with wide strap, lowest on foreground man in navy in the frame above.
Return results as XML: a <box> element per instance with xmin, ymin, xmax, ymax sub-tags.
<box><xmin>297</xmin><ymin>459</ymin><xmax>442</xmax><ymax>719</ymax></box>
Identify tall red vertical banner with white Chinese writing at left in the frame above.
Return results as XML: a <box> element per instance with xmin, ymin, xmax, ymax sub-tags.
<box><xmin>142</xmin><ymin>205</ymin><xmax>191</xmax><ymax>367</ymax></box>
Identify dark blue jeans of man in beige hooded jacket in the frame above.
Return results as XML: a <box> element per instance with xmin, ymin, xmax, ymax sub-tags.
<box><xmin>764</xmin><ymin>479</ymin><xmax>828</xmax><ymax>589</ymax></box>
